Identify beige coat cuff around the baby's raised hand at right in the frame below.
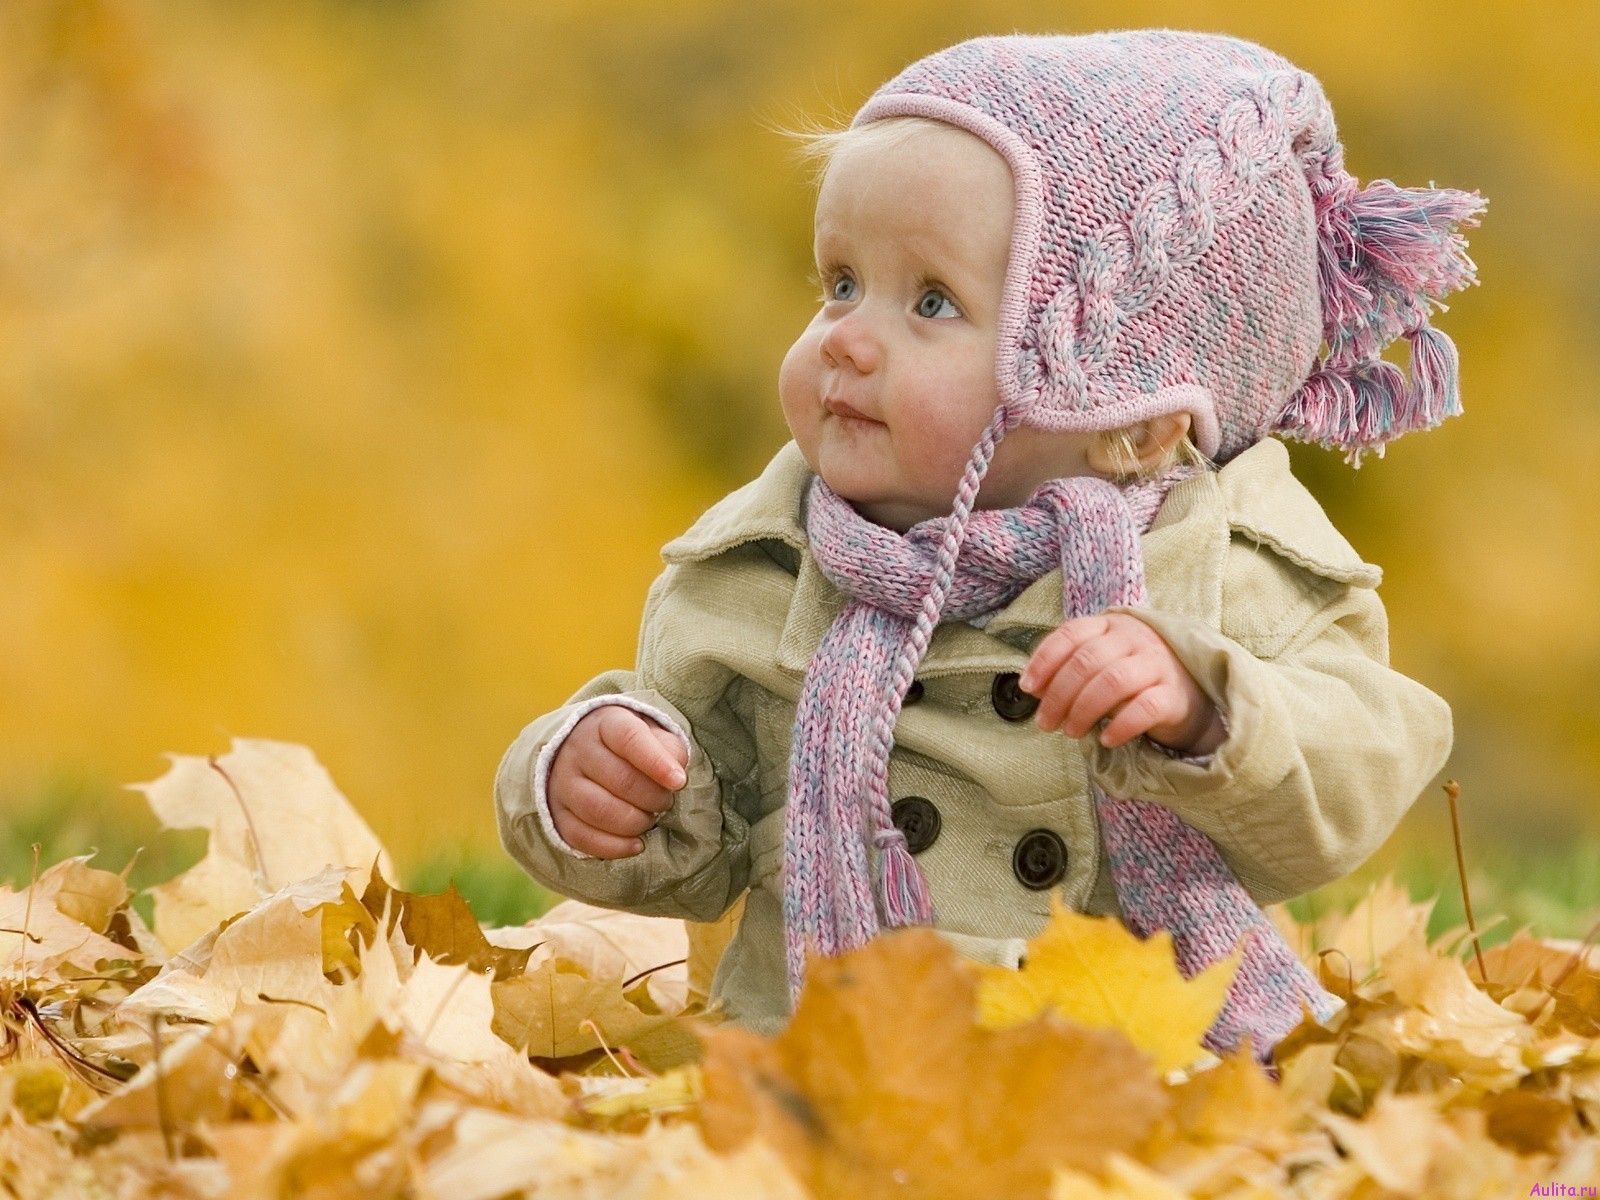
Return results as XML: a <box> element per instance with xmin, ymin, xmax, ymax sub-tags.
<box><xmin>1083</xmin><ymin>605</ymin><xmax>1294</xmax><ymax>814</ymax></box>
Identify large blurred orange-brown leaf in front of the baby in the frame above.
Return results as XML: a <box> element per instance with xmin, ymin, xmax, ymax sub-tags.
<box><xmin>701</xmin><ymin>928</ymin><xmax>1168</xmax><ymax>1200</ymax></box>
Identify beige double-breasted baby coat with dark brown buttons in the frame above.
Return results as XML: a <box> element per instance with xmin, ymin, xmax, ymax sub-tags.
<box><xmin>494</xmin><ymin>440</ymin><xmax>1451</xmax><ymax>1032</ymax></box>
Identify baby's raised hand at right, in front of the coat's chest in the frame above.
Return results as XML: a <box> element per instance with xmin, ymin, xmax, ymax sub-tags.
<box><xmin>1018</xmin><ymin>613</ymin><xmax>1227</xmax><ymax>755</ymax></box>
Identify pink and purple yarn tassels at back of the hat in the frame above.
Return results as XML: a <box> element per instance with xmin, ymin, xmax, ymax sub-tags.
<box><xmin>1275</xmin><ymin>160</ymin><xmax>1488</xmax><ymax>466</ymax></box>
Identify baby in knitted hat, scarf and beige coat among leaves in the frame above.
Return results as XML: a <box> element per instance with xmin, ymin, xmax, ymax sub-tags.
<box><xmin>496</xmin><ymin>30</ymin><xmax>1485</xmax><ymax>1056</ymax></box>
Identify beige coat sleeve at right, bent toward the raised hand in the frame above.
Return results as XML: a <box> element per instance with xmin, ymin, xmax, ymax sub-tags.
<box><xmin>1083</xmin><ymin>550</ymin><xmax>1453</xmax><ymax>904</ymax></box>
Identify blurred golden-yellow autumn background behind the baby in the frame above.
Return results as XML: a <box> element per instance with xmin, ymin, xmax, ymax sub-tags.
<box><xmin>0</xmin><ymin>0</ymin><xmax>1600</xmax><ymax>928</ymax></box>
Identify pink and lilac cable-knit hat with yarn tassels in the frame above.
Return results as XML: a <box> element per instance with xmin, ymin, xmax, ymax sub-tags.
<box><xmin>851</xmin><ymin>29</ymin><xmax>1486</xmax><ymax>464</ymax></box>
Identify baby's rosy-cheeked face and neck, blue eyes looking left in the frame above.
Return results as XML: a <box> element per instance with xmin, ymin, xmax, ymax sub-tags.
<box><xmin>778</xmin><ymin>125</ymin><xmax>1091</xmax><ymax>531</ymax></box>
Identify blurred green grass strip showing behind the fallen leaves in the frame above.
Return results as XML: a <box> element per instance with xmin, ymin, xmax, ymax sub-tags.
<box><xmin>0</xmin><ymin>779</ymin><xmax>1600</xmax><ymax>944</ymax></box>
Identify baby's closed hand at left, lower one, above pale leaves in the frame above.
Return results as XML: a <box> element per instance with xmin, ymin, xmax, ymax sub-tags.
<box><xmin>546</xmin><ymin>704</ymin><xmax>688</xmax><ymax>858</ymax></box>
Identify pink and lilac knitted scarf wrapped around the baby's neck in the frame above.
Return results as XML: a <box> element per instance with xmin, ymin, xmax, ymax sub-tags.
<box><xmin>784</xmin><ymin>470</ymin><xmax>1338</xmax><ymax>1058</ymax></box>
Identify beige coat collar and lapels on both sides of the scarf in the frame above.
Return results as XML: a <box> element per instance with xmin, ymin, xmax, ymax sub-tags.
<box><xmin>661</xmin><ymin>438</ymin><xmax>1382</xmax><ymax>677</ymax></box>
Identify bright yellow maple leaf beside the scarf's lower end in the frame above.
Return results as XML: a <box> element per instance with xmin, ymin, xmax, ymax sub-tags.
<box><xmin>978</xmin><ymin>896</ymin><xmax>1242</xmax><ymax>1070</ymax></box>
